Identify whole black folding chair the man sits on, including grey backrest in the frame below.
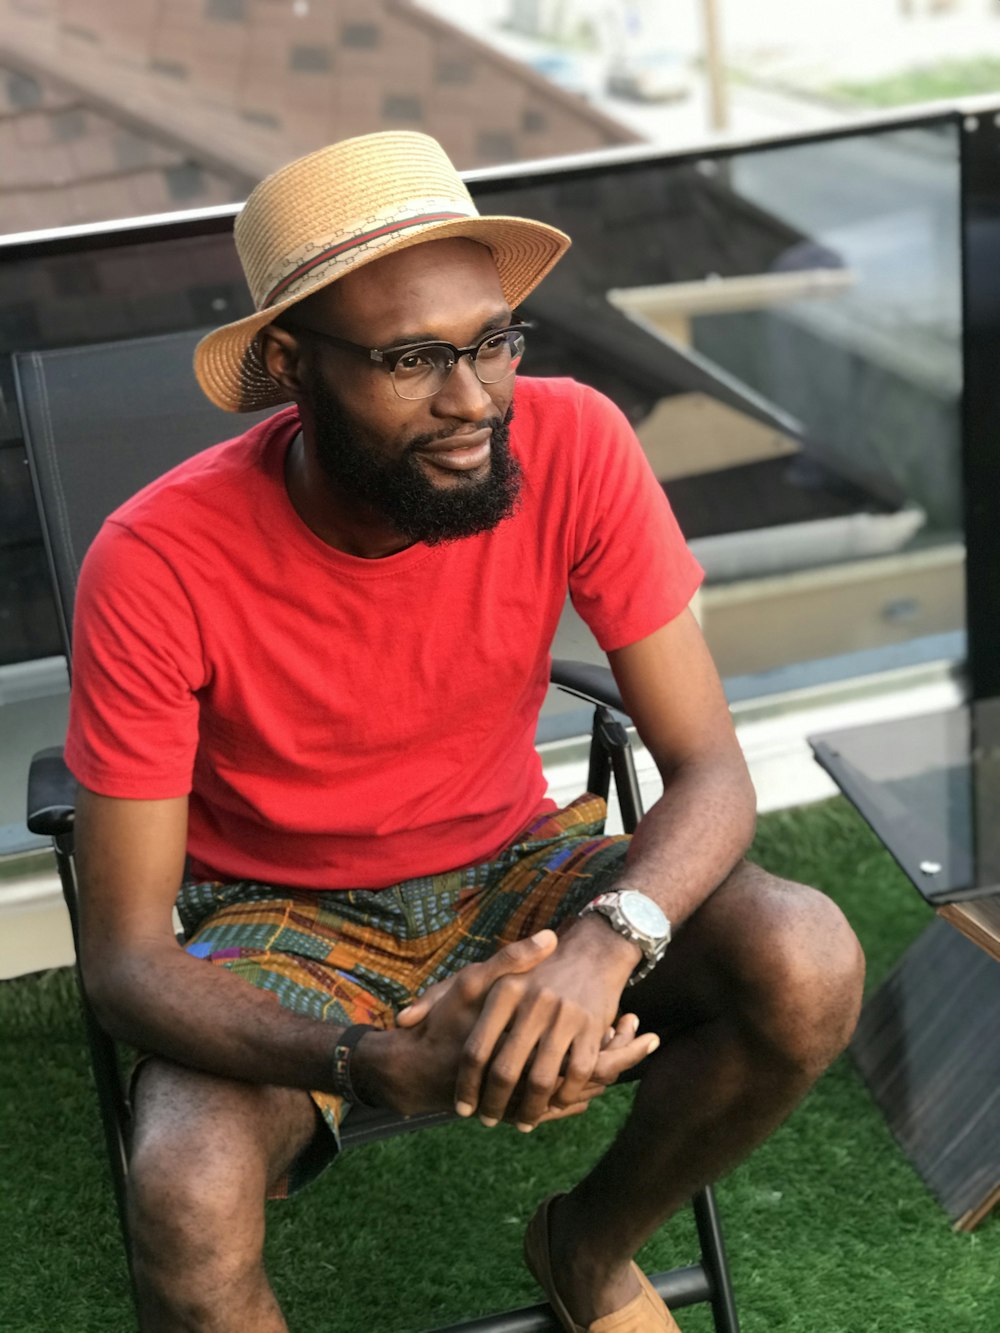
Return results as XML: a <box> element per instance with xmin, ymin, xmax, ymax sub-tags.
<box><xmin>15</xmin><ymin>331</ymin><xmax>739</xmax><ymax>1333</ymax></box>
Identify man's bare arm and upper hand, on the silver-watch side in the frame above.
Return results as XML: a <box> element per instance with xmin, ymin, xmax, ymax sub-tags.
<box><xmin>442</xmin><ymin>611</ymin><xmax>756</xmax><ymax>1125</ymax></box>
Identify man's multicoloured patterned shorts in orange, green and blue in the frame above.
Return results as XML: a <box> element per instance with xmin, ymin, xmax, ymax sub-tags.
<box><xmin>177</xmin><ymin>794</ymin><xmax>628</xmax><ymax>1197</ymax></box>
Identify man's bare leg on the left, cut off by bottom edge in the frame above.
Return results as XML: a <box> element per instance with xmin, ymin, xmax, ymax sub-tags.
<box><xmin>129</xmin><ymin>1060</ymin><xmax>318</xmax><ymax>1333</ymax></box>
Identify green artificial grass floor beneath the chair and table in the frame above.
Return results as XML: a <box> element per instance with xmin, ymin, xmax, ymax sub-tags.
<box><xmin>0</xmin><ymin>800</ymin><xmax>1000</xmax><ymax>1333</ymax></box>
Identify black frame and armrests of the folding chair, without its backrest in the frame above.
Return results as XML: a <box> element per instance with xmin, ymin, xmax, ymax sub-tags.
<box><xmin>28</xmin><ymin>661</ymin><xmax>739</xmax><ymax>1333</ymax></box>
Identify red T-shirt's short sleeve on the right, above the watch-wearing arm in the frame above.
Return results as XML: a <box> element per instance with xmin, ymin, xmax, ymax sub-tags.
<box><xmin>569</xmin><ymin>389</ymin><xmax>704</xmax><ymax>652</ymax></box>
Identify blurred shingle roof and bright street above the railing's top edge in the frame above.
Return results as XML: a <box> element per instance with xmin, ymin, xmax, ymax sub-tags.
<box><xmin>0</xmin><ymin>0</ymin><xmax>1000</xmax><ymax>233</ymax></box>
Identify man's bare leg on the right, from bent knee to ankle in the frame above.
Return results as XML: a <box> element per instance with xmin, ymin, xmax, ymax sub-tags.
<box><xmin>549</xmin><ymin>862</ymin><xmax>864</xmax><ymax>1326</ymax></box>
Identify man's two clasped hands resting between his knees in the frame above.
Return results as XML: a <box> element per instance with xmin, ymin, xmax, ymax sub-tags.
<box><xmin>381</xmin><ymin>930</ymin><xmax>659</xmax><ymax>1132</ymax></box>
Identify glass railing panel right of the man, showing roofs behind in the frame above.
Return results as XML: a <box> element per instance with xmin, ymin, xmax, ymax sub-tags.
<box><xmin>481</xmin><ymin>119</ymin><xmax>964</xmax><ymax>696</ymax></box>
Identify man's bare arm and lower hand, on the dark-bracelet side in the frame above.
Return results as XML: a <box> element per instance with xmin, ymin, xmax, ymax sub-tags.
<box><xmin>76</xmin><ymin>788</ymin><xmax>645</xmax><ymax>1114</ymax></box>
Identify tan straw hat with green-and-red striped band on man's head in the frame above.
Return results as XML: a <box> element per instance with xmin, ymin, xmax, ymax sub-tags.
<box><xmin>195</xmin><ymin>131</ymin><xmax>569</xmax><ymax>412</ymax></box>
